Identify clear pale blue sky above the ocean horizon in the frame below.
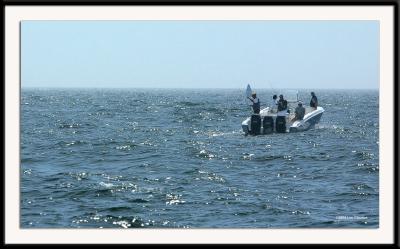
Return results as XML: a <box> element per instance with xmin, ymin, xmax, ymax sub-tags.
<box><xmin>21</xmin><ymin>21</ymin><xmax>379</xmax><ymax>89</ymax></box>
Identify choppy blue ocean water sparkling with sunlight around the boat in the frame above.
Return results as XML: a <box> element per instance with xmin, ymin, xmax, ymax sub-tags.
<box><xmin>20</xmin><ymin>89</ymin><xmax>379</xmax><ymax>228</ymax></box>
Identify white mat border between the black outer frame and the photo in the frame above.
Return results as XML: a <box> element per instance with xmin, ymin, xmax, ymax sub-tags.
<box><xmin>5</xmin><ymin>5</ymin><xmax>394</xmax><ymax>244</ymax></box>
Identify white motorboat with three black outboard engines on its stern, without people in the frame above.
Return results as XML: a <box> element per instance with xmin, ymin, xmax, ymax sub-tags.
<box><xmin>242</xmin><ymin>85</ymin><xmax>325</xmax><ymax>135</ymax></box>
